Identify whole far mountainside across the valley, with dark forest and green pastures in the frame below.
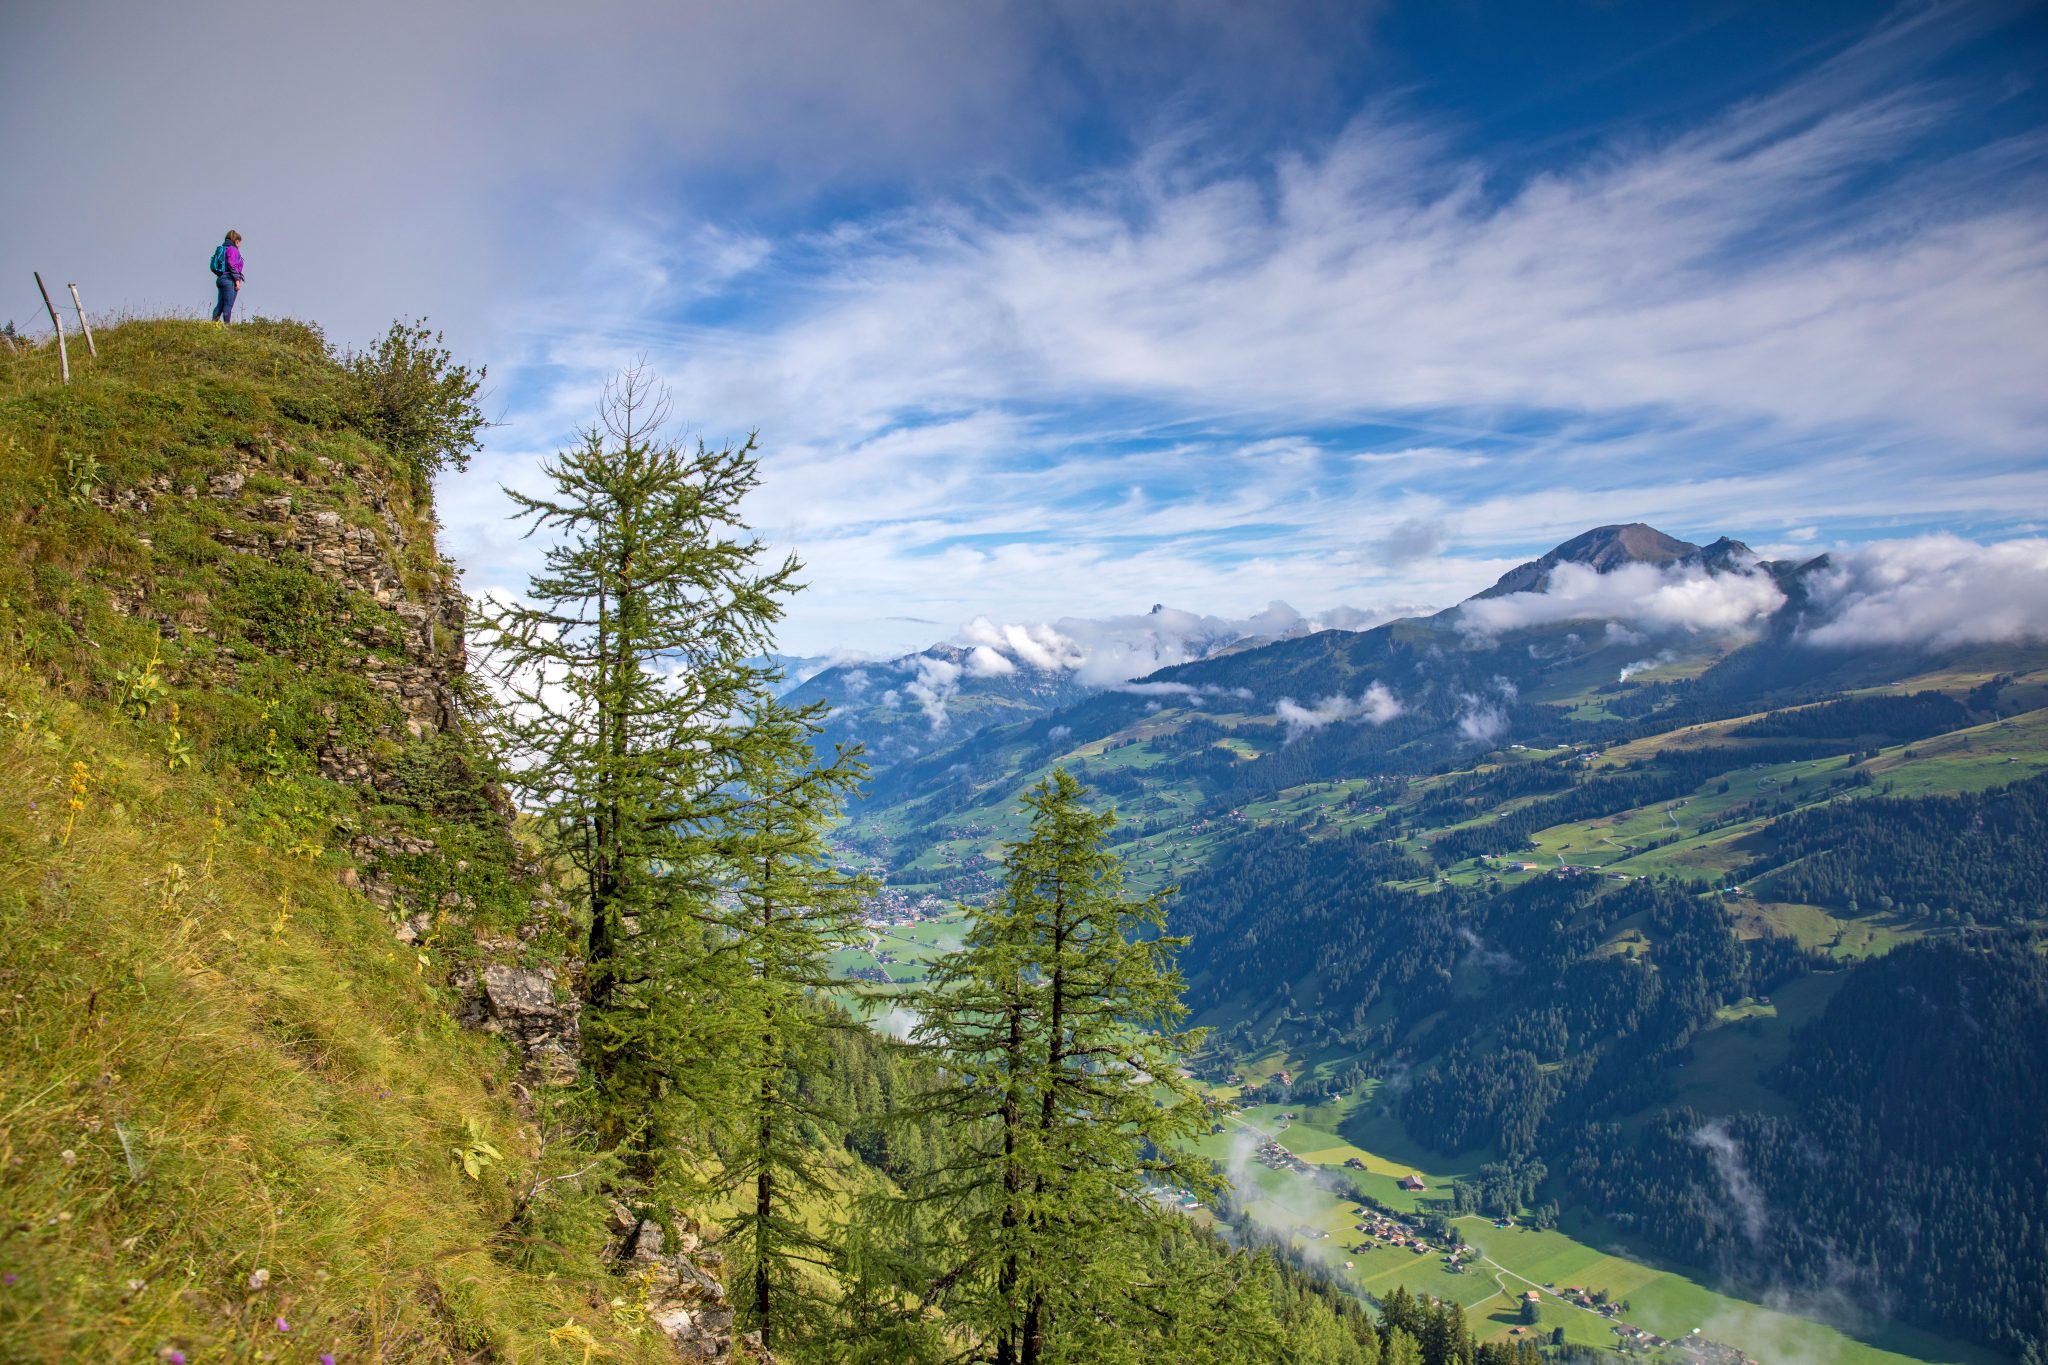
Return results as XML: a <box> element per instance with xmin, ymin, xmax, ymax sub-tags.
<box><xmin>848</xmin><ymin>519</ymin><xmax>2048</xmax><ymax>1357</ymax></box>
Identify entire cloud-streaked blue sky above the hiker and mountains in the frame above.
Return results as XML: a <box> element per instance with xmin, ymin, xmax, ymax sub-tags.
<box><xmin>12</xmin><ymin>0</ymin><xmax>2048</xmax><ymax>653</ymax></box>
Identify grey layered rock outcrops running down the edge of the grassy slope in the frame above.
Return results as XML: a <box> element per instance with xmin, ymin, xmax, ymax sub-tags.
<box><xmin>94</xmin><ymin>423</ymin><xmax>749</xmax><ymax>1363</ymax></box>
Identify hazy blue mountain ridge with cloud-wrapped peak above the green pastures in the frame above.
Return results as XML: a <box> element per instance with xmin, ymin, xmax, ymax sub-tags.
<box><xmin>839</xmin><ymin>524</ymin><xmax>1884</xmax><ymax>800</ymax></box>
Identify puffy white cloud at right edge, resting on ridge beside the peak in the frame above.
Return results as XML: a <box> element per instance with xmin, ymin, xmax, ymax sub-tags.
<box><xmin>1802</xmin><ymin>536</ymin><xmax>2048</xmax><ymax>649</ymax></box>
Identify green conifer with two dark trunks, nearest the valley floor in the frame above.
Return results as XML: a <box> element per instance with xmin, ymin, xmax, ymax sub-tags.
<box><xmin>913</xmin><ymin>769</ymin><xmax>1219</xmax><ymax>1365</ymax></box>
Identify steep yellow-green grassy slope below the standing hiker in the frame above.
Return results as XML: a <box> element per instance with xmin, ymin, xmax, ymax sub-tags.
<box><xmin>0</xmin><ymin>321</ymin><xmax>672</xmax><ymax>1361</ymax></box>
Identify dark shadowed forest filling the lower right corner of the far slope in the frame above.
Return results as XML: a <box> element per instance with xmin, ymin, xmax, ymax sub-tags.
<box><xmin>1563</xmin><ymin>933</ymin><xmax>2048</xmax><ymax>1359</ymax></box>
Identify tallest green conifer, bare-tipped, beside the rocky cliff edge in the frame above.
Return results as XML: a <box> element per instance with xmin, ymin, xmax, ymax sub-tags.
<box><xmin>477</xmin><ymin>370</ymin><xmax>799</xmax><ymax>1179</ymax></box>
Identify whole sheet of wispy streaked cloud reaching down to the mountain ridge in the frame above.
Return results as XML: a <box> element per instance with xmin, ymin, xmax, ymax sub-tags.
<box><xmin>444</xmin><ymin>10</ymin><xmax>2048</xmax><ymax>654</ymax></box>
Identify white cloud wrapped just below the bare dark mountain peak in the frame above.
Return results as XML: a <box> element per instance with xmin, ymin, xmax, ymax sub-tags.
<box><xmin>1458</xmin><ymin>563</ymin><xmax>1784</xmax><ymax>634</ymax></box>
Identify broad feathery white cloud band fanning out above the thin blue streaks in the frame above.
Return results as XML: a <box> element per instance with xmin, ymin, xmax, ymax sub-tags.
<box><xmin>626</xmin><ymin>25</ymin><xmax>2048</xmax><ymax>458</ymax></box>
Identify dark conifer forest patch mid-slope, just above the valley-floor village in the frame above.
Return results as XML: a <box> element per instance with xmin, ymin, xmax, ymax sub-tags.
<box><xmin>1171</xmin><ymin>829</ymin><xmax>1819</xmax><ymax>1129</ymax></box>
